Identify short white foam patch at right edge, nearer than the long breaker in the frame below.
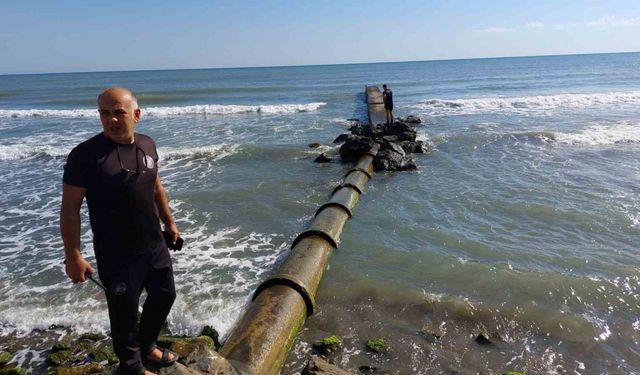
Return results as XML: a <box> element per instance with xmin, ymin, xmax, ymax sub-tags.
<box><xmin>554</xmin><ymin>122</ymin><xmax>640</xmax><ymax>146</ymax></box>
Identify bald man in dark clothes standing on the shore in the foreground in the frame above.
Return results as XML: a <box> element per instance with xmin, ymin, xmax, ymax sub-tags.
<box><xmin>60</xmin><ymin>87</ymin><xmax>180</xmax><ymax>375</ymax></box>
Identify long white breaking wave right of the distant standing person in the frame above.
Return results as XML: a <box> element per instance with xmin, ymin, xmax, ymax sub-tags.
<box><xmin>412</xmin><ymin>91</ymin><xmax>640</xmax><ymax>115</ymax></box>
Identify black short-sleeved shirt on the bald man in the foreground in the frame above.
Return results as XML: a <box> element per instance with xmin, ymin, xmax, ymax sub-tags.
<box><xmin>62</xmin><ymin>133</ymin><xmax>164</xmax><ymax>260</ymax></box>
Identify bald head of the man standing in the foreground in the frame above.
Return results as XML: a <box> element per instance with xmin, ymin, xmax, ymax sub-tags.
<box><xmin>98</xmin><ymin>90</ymin><xmax>140</xmax><ymax>144</ymax></box>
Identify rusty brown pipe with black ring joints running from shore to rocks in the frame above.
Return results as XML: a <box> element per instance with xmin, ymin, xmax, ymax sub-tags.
<box><xmin>220</xmin><ymin>144</ymin><xmax>379</xmax><ymax>375</ymax></box>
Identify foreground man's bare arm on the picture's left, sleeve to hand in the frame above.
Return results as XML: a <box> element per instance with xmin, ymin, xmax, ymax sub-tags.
<box><xmin>60</xmin><ymin>183</ymin><xmax>93</xmax><ymax>283</ymax></box>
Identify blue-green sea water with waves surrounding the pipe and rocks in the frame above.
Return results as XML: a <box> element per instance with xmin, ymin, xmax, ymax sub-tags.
<box><xmin>0</xmin><ymin>53</ymin><xmax>640</xmax><ymax>374</ymax></box>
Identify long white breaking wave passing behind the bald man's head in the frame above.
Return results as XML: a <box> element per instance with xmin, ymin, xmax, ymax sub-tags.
<box><xmin>0</xmin><ymin>102</ymin><xmax>326</xmax><ymax>118</ymax></box>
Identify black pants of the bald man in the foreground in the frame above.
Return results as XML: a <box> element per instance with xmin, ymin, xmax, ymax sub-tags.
<box><xmin>98</xmin><ymin>246</ymin><xmax>176</xmax><ymax>375</ymax></box>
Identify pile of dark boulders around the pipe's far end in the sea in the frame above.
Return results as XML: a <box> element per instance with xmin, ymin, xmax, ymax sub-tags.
<box><xmin>333</xmin><ymin>116</ymin><xmax>431</xmax><ymax>171</ymax></box>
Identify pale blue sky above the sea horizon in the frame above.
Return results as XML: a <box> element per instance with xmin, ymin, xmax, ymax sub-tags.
<box><xmin>0</xmin><ymin>0</ymin><xmax>640</xmax><ymax>74</ymax></box>
